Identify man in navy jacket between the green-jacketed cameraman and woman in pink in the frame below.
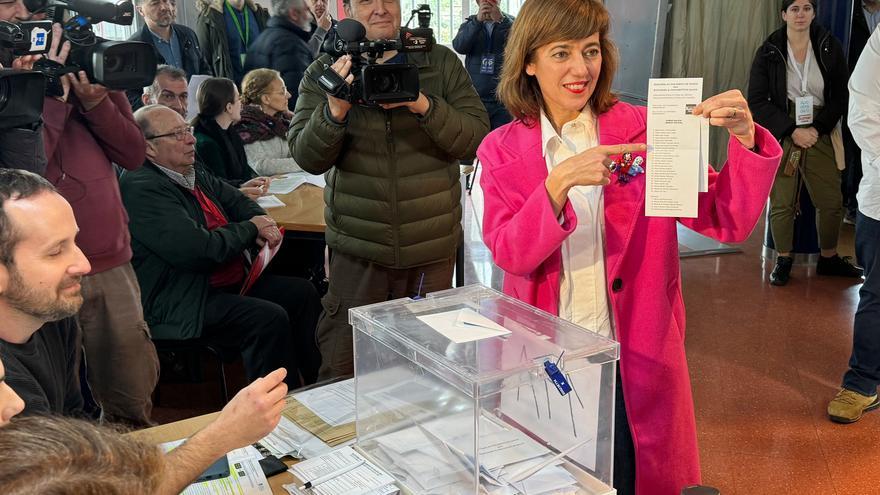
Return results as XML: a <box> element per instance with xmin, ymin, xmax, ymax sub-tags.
<box><xmin>452</xmin><ymin>0</ymin><xmax>514</xmax><ymax>129</ymax></box>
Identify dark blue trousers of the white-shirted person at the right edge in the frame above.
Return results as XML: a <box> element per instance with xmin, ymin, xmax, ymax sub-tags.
<box><xmin>843</xmin><ymin>212</ymin><xmax>880</xmax><ymax>395</ymax></box>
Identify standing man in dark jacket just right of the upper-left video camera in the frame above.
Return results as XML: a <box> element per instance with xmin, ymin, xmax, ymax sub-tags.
<box><xmin>127</xmin><ymin>0</ymin><xmax>213</xmax><ymax>110</ymax></box>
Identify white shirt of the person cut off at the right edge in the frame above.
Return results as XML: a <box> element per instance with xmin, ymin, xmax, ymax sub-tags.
<box><xmin>847</xmin><ymin>27</ymin><xmax>880</xmax><ymax>221</ymax></box>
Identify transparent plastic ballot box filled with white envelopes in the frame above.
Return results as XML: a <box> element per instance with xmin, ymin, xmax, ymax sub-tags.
<box><xmin>349</xmin><ymin>285</ymin><xmax>618</xmax><ymax>495</ymax></box>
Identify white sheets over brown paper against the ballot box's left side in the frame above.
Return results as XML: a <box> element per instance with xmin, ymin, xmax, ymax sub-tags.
<box><xmin>283</xmin><ymin>379</ymin><xmax>355</xmax><ymax>447</ymax></box>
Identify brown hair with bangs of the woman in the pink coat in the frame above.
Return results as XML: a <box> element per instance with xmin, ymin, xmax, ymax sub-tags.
<box><xmin>497</xmin><ymin>0</ymin><xmax>618</xmax><ymax>126</ymax></box>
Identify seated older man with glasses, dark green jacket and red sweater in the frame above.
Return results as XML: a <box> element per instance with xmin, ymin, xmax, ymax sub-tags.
<box><xmin>120</xmin><ymin>105</ymin><xmax>321</xmax><ymax>385</ymax></box>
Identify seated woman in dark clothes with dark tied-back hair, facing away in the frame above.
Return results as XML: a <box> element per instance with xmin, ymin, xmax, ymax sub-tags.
<box><xmin>192</xmin><ymin>77</ymin><xmax>269</xmax><ymax>199</ymax></box>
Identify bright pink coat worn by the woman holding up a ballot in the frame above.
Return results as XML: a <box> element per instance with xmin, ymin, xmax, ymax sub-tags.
<box><xmin>477</xmin><ymin>103</ymin><xmax>782</xmax><ymax>495</ymax></box>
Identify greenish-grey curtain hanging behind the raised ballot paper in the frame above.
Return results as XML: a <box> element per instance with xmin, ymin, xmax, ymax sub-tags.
<box><xmin>661</xmin><ymin>0</ymin><xmax>782</xmax><ymax>168</ymax></box>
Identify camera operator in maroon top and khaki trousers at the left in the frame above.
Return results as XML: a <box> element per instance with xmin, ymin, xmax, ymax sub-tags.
<box><xmin>32</xmin><ymin>24</ymin><xmax>159</xmax><ymax>425</ymax></box>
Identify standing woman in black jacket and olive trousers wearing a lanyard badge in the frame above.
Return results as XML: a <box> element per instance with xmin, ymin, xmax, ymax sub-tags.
<box><xmin>748</xmin><ymin>0</ymin><xmax>862</xmax><ymax>285</ymax></box>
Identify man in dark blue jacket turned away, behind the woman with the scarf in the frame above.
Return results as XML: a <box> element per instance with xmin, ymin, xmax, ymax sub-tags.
<box><xmin>244</xmin><ymin>0</ymin><xmax>314</xmax><ymax>110</ymax></box>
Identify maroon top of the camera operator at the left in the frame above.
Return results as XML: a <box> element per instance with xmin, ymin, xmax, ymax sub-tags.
<box><xmin>43</xmin><ymin>91</ymin><xmax>146</xmax><ymax>274</ymax></box>
